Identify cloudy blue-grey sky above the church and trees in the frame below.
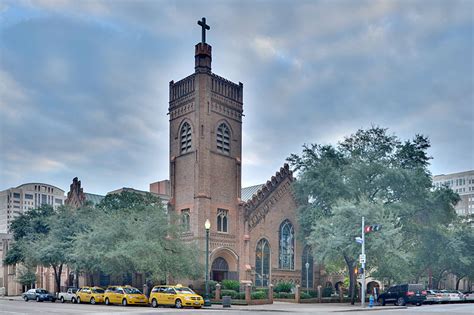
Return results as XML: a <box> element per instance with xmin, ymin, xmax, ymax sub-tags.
<box><xmin>0</xmin><ymin>0</ymin><xmax>474</xmax><ymax>194</ymax></box>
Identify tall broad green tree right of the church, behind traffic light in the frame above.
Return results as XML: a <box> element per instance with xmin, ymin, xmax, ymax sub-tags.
<box><xmin>288</xmin><ymin>127</ymin><xmax>454</xmax><ymax>302</ymax></box>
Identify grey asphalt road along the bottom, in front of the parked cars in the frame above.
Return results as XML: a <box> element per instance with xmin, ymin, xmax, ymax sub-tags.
<box><xmin>0</xmin><ymin>300</ymin><xmax>474</xmax><ymax>315</ymax></box>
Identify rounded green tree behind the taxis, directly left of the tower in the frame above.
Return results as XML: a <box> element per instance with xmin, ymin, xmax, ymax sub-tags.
<box><xmin>73</xmin><ymin>192</ymin><xmax>202</xmax><ymax>281</ymax></box>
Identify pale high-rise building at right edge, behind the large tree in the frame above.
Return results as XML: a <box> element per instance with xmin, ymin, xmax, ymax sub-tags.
<box><xmin>433</xmin><ymin>170</ymin><xmax>474</xmax><ymax>215</ymax></box>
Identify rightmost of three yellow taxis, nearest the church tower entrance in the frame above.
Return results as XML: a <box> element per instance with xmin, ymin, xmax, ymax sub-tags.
<box><xmin>148</xmin><ymin>284</ymin><xmax>204</xmax><ymax>308</ymax></box>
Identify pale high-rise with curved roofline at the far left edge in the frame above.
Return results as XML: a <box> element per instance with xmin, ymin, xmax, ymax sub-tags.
<box><xmin>0</xmin><ymin>183</ymin><xmax>66</xmax><ymax>233</ymax></box>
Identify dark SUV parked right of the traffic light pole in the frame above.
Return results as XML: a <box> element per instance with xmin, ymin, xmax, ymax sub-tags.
<box><xmin>377</xmin><ymin>284</ymin><xmax>426</xmax><ymax>306</ymax></box>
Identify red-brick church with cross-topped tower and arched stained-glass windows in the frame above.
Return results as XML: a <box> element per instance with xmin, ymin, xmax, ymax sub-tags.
<box><xmin>168</xmin><ymin>18</ymin><xmax>320</xmax><ymax>288</ymax></box>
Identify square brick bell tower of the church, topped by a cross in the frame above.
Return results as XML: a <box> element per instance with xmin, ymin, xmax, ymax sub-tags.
<box><xmin>168</xmin><ymin>18</ymin><xmax>243</xmax><ymax>278</ymax></box>
